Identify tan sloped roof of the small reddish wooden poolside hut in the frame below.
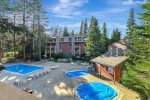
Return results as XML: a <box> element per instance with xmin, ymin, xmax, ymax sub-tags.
<box><xmin>91</xmin><ymin>56</ymin><xmax>128</xmax><ymax>68</ymax></box>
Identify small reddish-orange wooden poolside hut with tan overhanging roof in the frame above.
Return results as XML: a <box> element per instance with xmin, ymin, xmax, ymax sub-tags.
<box><xmin>91</xmin><ymin>55</ymin><xmax>128</xmax><ymax>83</ymax></box>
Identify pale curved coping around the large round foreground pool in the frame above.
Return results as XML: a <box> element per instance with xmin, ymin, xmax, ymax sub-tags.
<box><xmin>74</xmin><ymin>81</ymin><xmax>119</xmax><ymax>100</ymax></box>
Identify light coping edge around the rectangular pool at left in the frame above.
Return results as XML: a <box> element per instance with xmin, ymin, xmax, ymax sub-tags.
<box><xmin>3</xmin><ymin>63</ymin><xmax>44</xmax><ymax>76</ymax></box>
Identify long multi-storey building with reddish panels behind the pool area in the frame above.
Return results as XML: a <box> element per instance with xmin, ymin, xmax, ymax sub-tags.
<box><xmin>45</xmin><ymin>36</ymin><xmax>86</xmax><ymax>58</ymax></box>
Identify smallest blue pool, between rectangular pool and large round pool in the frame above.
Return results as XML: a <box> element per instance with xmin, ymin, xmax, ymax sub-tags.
<box><xmin>66</xmin><ymin>70</ymin><xmax>89</xmax><ymax>78</ymax></box>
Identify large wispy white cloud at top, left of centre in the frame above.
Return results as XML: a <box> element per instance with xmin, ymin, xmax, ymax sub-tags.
<box><xmin>52</xmin><ymin>0</ymin><xmax>88</xmax><ymax>18</ymax></box>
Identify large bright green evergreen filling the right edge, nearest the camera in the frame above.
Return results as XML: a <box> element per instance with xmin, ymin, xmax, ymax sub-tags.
<box><xmin>122</xmin><ymin>0</ymin><xmax>150</xmax><ymax>100</ymax></box>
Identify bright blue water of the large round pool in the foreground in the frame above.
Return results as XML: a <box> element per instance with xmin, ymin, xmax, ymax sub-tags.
<box><xmin>76</xmin><ymin>82</ymin><xmax>117</xmax><ymax>100</ymax></box>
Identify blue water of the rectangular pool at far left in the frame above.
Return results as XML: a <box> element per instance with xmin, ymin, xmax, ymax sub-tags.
<box><xmin>5</xmin><ymin>64</ymin><xmax>44</xmax><ymax>75</ymax></box>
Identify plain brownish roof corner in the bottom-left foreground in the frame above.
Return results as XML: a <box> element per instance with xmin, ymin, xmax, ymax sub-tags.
<box><xmin>0</xmin><ymin>82</ymin><xmax>41</xmax><ymax>100</ymax></box>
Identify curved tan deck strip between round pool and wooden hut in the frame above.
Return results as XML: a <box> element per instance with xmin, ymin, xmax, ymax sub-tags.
<box><xmin>83</xmin><ymin>73</ymin><xmax>140</xmax><ymax>100</ymax></box>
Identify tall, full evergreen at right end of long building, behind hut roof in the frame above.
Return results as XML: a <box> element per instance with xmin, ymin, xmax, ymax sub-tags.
<box><xmin>86</xmin><ymin>16</ymin><xmax>101</xmax><ymax>58</ymax></box>
